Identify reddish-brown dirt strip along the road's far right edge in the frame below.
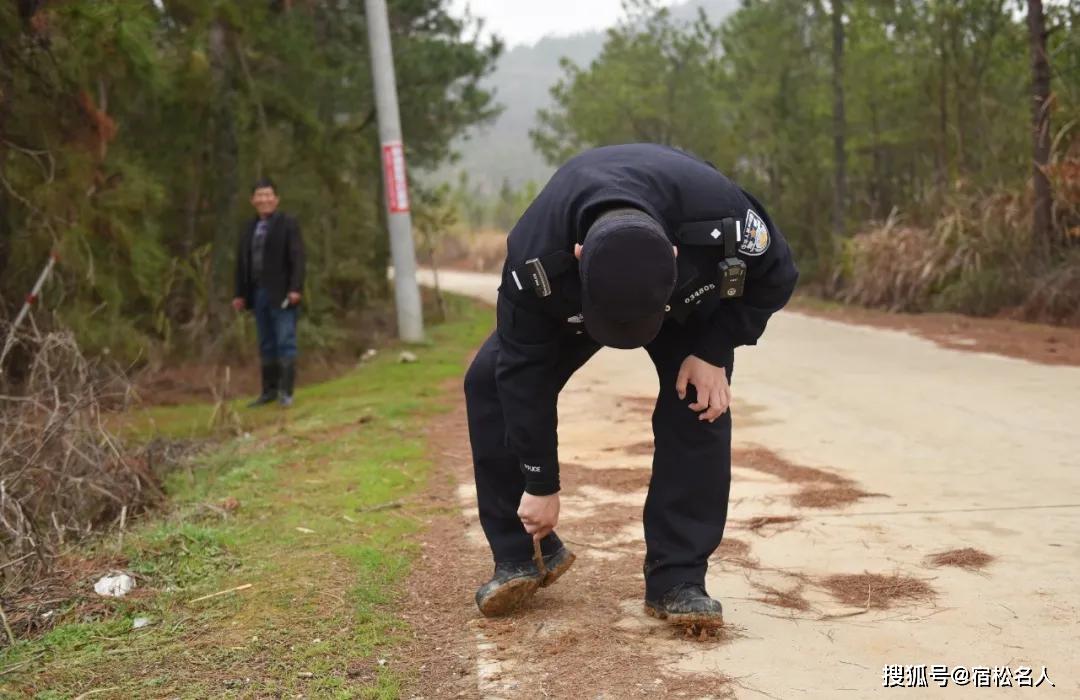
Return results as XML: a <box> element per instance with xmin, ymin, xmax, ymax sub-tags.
<box><xmin>788</xmin><ymin>297</ymin><xmax>1080</xmax><ymax>366</ymax></box>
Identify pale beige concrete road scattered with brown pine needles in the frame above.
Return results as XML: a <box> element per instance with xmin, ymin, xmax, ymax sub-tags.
<box><xmin>416</xmin><ymin>266</ymin><xmax>1080</xmax><ymax>698</ymax></box>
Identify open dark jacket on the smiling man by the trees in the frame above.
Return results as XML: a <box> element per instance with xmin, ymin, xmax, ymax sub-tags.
<box><xmin>235</xmin><ymin>212</ymin><xmax>303</xmax><ymax>309</ymax></box>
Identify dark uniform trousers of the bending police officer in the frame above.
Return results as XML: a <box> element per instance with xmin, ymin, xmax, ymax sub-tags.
<box><xmin>465</xmin><ymin>321</ymin><xmax>731</xmax><ymax>600</ymax></box>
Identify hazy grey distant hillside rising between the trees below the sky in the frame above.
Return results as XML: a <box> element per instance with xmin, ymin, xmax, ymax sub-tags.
<box><xmin>436</xmin><ymin>0</ymin><xmax>739</xmax><ymax>191</ymax></box>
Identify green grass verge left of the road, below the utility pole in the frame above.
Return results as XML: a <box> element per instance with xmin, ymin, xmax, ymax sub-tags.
<box><xmin>0</xmin><ymin>298</ymin><xmax>492</xmax><ymax>699</ymax></box>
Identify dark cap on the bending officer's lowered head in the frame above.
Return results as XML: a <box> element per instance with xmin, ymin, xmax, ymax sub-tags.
<box><xmin>579</xmin><ymin>208</ymin><xmax>677</xmax><ymax>350</ymax></box>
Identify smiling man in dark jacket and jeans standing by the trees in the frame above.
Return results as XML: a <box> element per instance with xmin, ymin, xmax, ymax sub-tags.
<box><xmin>232</xmin><ymin>178</ymin><xmax>303</xmax><ymax>407</ymax></box>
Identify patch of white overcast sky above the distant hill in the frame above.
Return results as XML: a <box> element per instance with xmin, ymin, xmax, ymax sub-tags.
<box><xmin>450</xmin><ymin>0</ymin><xmax>672</xmax><ymax>46</ymax></box>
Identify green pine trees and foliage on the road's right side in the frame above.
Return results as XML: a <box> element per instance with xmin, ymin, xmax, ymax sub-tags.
<box><xmin>532</xmin><ymin>0</ymin><xmax>1080</xmax><ymax>312</ymax></box>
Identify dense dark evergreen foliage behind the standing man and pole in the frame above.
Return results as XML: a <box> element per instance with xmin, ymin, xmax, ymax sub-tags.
<box><xmin>0</xmin><ymin>0</ymin><xmax>501</xmax><ymax>359</ymax></box>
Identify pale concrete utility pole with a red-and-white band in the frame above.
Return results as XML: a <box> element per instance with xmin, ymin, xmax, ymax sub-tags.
<box><xmin>364</xmin><ymin>0</ymin><xmax>423</xmax><ymax>342</ymax></box>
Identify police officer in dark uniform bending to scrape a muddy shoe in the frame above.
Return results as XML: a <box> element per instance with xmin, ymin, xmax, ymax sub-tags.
<box><xmin>464</xmin><ymin>144</ymin><xmax>798</xmax><ymax>624</ymax></box>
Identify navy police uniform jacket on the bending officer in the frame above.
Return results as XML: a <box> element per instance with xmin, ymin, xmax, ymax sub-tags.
<box><xmin>496</xmin><ymin>144</ymin><xmax>798</xmax><ymax>495</ymax></box>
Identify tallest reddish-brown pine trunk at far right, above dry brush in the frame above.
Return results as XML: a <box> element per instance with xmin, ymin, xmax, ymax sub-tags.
<box><xmin>1027</xmin><ymin>0</ymin><xmax>1053</xmax><ymax>254</ymax></box>
